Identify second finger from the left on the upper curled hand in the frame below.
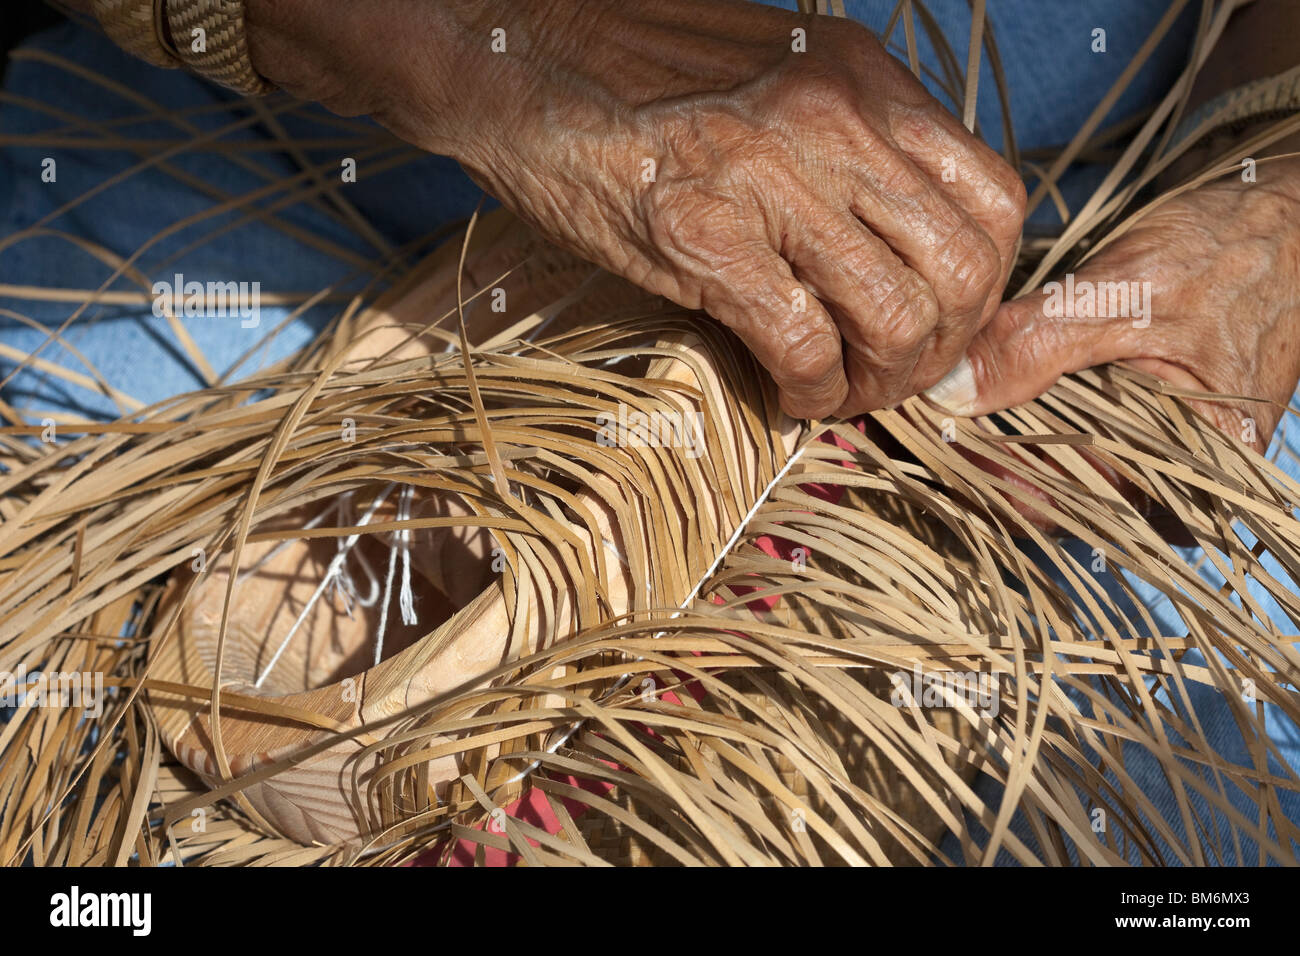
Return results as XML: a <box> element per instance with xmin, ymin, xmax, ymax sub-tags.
<box><xmin>783</xmin><ymin>212</ymin><xmax>939</xmax><ymax>418</ymax></box>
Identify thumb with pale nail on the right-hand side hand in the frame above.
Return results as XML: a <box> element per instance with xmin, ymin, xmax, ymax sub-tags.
<box><xmin>924</xmin><ymin>282</ymin><xmax>1151</xmax><ymax>416</ymax></box>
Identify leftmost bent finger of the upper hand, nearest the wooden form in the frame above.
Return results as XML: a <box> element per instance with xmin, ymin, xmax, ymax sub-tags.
<box><xmin>701</xmin><ymin>243</ymin><xmax>849</xmax><ymax>419</ymax></box>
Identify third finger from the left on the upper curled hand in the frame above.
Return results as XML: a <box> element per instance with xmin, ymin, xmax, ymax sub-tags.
<box><xmin>850</xmin><ymin>151</ymin><xmax>1002</xmax><ymax>390</ymax></box>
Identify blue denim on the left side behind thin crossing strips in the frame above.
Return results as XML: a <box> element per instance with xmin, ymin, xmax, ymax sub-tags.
<box><xmin>0</xmin><ymin>23</ymin><xmax>482</xmax><ymax>418</ymax></box>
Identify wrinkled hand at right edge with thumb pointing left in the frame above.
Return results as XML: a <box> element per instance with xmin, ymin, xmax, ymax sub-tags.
<box><xmin>930</xmin><ymin>159</ymin><xmax>1300</xmax><ymax>451</ymax></box>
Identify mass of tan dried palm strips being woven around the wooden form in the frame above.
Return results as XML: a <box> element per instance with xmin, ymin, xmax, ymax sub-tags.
<box><xmin>0</xmin><ymin>0</ymin><xmax>1300</xmax><ymax>865</ymax></box>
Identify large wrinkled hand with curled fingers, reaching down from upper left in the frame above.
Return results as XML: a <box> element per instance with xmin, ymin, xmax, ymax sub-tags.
<box><xmin>250</xmin><ymin>0</ymin><xmax>1024</xmax><ymax>418</ymax></box>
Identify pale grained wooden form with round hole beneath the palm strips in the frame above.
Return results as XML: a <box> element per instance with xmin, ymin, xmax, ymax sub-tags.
<box><xmin>142</xmin><ymin>213</ymin><xmax>796</xmax><ymax>843</ymax></box>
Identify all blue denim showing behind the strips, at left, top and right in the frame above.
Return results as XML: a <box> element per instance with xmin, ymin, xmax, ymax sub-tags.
<box><xmin>0</xmin><ymin>0</ymin><xmax>1300</xmax><ymax>864</ymax></box>
